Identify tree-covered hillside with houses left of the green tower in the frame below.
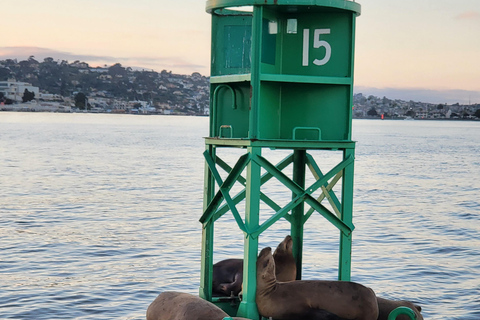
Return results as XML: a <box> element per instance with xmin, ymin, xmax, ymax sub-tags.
<box><xmin>0</xmin><ymin>57</ymin><xmax>209</xmax><ymax>115</ymax></box>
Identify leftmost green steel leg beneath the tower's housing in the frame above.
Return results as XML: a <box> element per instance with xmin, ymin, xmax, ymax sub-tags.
<box><xmin>199</xmin><ymin>146</ymin><xmax>215</xmax><ymax>301</ymax></box>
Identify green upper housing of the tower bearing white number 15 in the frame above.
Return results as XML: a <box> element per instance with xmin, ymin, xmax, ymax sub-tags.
<box><xmin>207</xmin><ymin>0</ymin><xmax>360</xmax><ymax>141</ymax></box>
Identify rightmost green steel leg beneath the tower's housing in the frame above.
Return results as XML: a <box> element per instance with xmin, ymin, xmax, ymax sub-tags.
<box><xmin>338</xmin><ymin>149</ymin><xmax>355</xmax><ymax>281</ymax></box>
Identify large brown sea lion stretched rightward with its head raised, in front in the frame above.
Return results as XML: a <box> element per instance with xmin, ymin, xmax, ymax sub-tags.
<box><xmin>256</xmin><ymin>247</ymin><xmax>378</xmax><ymax>320</ymax></box>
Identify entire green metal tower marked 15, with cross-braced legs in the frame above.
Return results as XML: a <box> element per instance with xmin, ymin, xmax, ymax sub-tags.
<box><xmin>200</xmin><ymin>0</ymin><xmax>360</xmax><ymax>319</ymax></box>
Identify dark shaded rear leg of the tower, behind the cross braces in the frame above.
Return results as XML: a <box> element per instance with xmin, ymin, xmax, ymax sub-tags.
<box><xmin>291</xmin><ymin>150</ymin><xmax>307</xmax><ymax>280</ymax></box>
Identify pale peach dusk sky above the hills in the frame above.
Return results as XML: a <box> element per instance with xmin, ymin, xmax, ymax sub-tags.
<box><xmin>0</xmin><ymin>0</ymin><xmax>480</xmax><ymax>103</ymax></box>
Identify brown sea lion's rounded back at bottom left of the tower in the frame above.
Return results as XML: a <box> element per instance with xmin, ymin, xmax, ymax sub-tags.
<box><xmin>147</xmin><ymin>291</ymin><xmax>249</xmax><ymax>320</ymax></box>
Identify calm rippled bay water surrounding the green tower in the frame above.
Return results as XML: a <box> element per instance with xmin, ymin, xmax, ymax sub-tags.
<box><xmin>0</xmin><ymin>112</ymin><xmax>480</xmax><ymax>320</ymax></box>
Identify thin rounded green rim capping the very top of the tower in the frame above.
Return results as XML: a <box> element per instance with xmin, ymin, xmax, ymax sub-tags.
<box><xmin>206</xmin><ymin>0</ymin><xmax>361</xmax><ymax>15</ymax></box>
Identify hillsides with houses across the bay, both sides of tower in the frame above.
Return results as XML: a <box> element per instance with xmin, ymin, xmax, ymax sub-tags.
<box><xmin>0</xmin><ymin>56</ymin><xmax>480</xmax><ymax>120</ymax></box>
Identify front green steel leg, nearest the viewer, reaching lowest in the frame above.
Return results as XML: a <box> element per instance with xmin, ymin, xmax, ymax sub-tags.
<box><xmin>237</xmin><ymin>148</ymin><xmax>261</xmax><ymax>319</ymax></box>
